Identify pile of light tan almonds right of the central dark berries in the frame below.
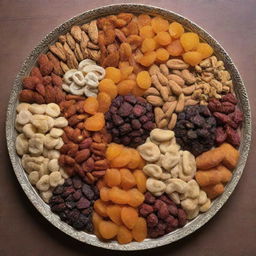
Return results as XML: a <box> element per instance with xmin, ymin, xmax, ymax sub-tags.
<box><xmin>144</xmin><ymin>59</ymin><xmax>198</xmax><ymax>130</ymax></box>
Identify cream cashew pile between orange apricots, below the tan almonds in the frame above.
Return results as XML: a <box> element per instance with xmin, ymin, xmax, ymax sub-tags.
<box><xmin>137</xmin><ymin>128</ymin><xmax>211</xmax><ymax>219</ymax></box>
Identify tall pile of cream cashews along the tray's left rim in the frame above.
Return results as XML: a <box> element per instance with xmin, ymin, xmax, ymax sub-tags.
<box><xmin>15</xmin><ymin>103</ymin><xmax>68</xmax><ymax>203</ymax></box>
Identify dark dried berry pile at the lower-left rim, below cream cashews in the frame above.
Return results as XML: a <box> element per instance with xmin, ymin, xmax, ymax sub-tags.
<box><xmin>49</xmin><ymin>176</ymin><xmax>99</xmax><ymax>232</ymax></box>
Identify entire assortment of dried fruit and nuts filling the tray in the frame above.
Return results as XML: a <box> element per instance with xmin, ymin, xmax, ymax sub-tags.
<box><xmin>15</xmin><ymin>13</ymin><xmax>243</xmax><ymax>244</ymax></box>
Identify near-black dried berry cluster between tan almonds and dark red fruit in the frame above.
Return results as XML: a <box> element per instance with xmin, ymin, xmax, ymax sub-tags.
<box><xmin>174</xmin><ymin>105</ymin><xmax>216</xmax><ymax>156</ymax></box>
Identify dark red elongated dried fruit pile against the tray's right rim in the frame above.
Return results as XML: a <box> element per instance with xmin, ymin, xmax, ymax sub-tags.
<box><xmin>208</xmin><ymin>93</ymin><xmax>243</xmax><ymax>147</ymax></box>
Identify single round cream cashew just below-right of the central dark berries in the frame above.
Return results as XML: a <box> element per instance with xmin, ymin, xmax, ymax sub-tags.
<box><xmin>137</xmin><ymin>142</ymin><xmax>160</xmax><ymax>163</ymax></box>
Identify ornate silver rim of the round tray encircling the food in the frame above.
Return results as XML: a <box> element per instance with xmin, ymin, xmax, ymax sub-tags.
<box><xmin>6</xmin><ymin>4</ymin><xmax>251</xmax><ymax>251</ymax></box>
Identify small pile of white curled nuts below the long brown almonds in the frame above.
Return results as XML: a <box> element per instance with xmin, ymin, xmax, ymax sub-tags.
<box><xmin>62</xmin><ymin>59</ymin><xmax>105</xmax><ymax>97</ymax></box>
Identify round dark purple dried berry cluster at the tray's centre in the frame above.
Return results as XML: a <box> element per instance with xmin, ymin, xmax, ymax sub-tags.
<box><xmin>105</xmin><ymin>95</ymin><xmax>155</xmax><ymax>147</ymax></box>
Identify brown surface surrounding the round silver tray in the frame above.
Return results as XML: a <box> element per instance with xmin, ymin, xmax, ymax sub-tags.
<box><xmin>0</xmin><ymin>0</ymin><xmax>256</xmax><ymax>256</ymax></box>
